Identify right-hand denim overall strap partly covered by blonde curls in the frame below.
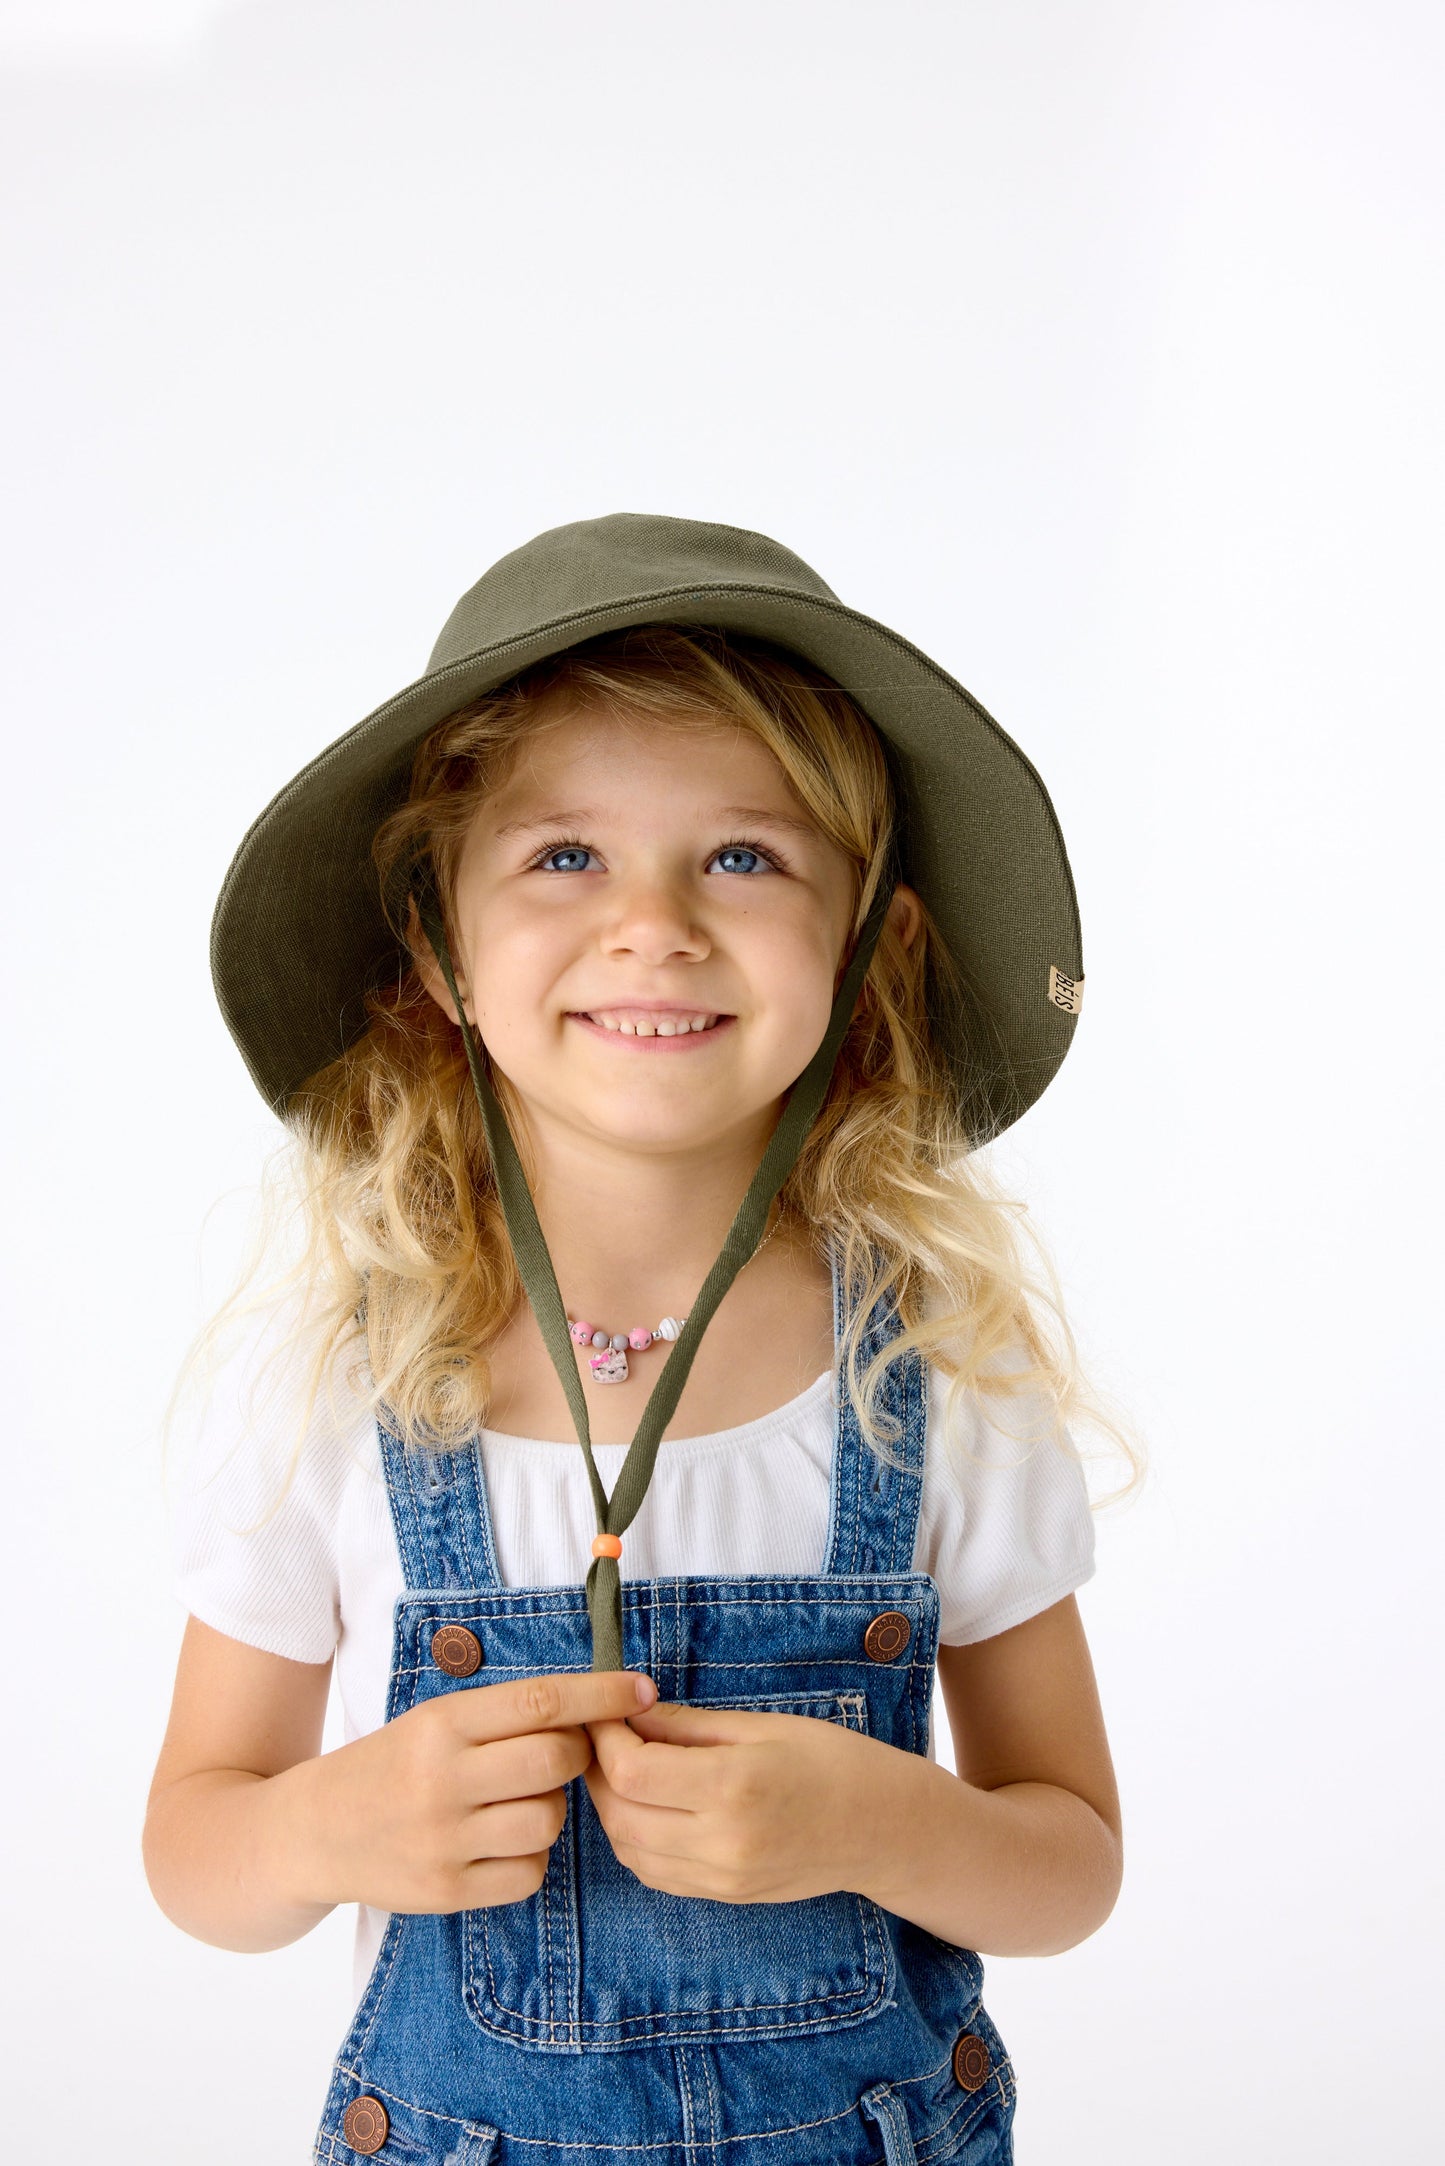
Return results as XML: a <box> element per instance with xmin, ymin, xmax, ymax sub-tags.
<box><xmin>823</xmin><ymin>1252</ymin><xmax>927</xmax><ymax>1577</ymax></box>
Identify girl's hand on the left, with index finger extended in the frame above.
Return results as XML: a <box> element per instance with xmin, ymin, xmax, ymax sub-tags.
<box><xmin>303</xmin><ymin>1670</ymin><xmax>656</xmax><ymax>1913</ymax></box>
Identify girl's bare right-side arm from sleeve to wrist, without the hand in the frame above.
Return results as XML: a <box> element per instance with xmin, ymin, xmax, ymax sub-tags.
<box><xmin>851</xmin><ymin>1594</ymin><xmax>1124</xmax><ymax>1956</ymax></box>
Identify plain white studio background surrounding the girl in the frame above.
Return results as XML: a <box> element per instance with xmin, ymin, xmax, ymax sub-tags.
<box><xmin>0</xmin><ymin>0</ymin><xmax>1445</xmax><ymax>2166</ymax></box>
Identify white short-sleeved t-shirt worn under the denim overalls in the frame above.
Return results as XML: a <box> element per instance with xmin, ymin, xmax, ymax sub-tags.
<box><xmin>173</xmin><ymin>1304</ymin><xmax>1094</xmax><ymax>1997</ymax></box>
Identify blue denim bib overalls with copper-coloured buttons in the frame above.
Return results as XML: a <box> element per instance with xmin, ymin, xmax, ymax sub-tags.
<box><xmin>314</xmin><ymin>1258</ymin><xmax>1014</xmax><ymax>2166</ymax></box>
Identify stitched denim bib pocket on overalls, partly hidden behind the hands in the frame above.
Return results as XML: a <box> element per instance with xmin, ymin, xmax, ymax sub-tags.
<box><xmin>461</xmin><ymin>1692</ymin><xmax>897</xmax><ymax>2053</ymax></box>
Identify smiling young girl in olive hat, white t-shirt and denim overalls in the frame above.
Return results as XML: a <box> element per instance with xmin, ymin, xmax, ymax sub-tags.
<box><xmin>145</xmin><ymin>516</ymin><xmax>1133</xmax><ymax>2166</ymax></box>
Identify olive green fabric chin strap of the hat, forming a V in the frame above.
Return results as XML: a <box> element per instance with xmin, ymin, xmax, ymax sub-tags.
<box><xmin>416</xmin><ymin>879</ymin><xmax>893</xmax><ymax>1670</ymax></box>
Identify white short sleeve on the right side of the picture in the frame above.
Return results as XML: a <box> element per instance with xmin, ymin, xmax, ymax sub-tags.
<box><xmin>914</xmin><ymin>1369</ymin><xmax>1094</xmax><ymax>1646</ymax></box>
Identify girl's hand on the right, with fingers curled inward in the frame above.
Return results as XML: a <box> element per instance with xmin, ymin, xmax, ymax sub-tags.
<box><xmin>583</xmin><ymin>1702</ymin><xmax>893</xmax><ymax>1902</ymax></box>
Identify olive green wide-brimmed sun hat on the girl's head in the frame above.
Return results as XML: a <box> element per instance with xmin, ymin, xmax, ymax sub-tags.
<box><xmin>210</xmin><ymin>511</ymin><xmax>1083</xmax><ymax>1135</ymax></box>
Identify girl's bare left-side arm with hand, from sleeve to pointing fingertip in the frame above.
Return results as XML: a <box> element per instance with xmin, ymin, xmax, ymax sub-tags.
<box><xmin>143</xmin><ymin>1618</ymin><xmax>652</xmax><ymax>1954</ymax></box>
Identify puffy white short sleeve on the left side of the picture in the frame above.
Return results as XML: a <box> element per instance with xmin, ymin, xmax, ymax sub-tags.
<box><xmin>167</xmin><ymin>1306</ymin><xmax>370</xmax><ymax>1661</ymax></box>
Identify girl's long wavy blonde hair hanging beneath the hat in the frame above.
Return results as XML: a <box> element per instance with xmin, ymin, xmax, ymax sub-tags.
<box><xmin>167</xmin><ymin>624</ymin><xmax>1144</xmax><ymax>1503</ymax></box>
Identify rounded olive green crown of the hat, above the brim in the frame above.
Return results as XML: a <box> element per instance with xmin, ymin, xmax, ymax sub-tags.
<box><xmin>427</xmin><ymin>511</ymin><xmax>838</xmax><ymax>671</ymax></box>
